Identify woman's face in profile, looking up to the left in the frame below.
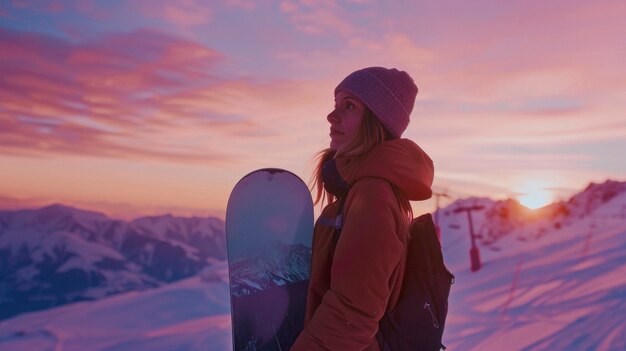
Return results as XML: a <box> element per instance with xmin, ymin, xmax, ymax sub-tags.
<box><xmin>326</xmin><ymin>91</ymin><xmax>365</xmax><ymax>150</ymax></box>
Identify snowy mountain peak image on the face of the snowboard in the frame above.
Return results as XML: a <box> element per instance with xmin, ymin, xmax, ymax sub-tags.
<box><xmin>231</xmin><ymin>241</ymin><xmax>311</xmax><ymax>296</ymax></box>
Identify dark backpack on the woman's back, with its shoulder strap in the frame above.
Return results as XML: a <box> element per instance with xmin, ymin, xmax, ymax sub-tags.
<box><xmin>334</xmin><ymin>194</ymin><xmax>454</xmax><ymax>351</ymax></box>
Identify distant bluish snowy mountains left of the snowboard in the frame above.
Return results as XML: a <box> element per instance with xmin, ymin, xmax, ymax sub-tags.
<box><xmin>0</xmin><ymin>205</ymin><xmax>226</xmax><ymax>319</ymax></box>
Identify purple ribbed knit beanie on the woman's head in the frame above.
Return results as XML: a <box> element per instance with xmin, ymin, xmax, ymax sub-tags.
<box><xmin>335</xmin><ymin>67</ymin><xmax>417</xmax><ymax>138</ymax></box>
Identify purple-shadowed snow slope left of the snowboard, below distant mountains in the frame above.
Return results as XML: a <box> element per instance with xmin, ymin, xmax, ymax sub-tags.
<box><xmin>0</xmin><ymin>262</ymin><xmax>231</xmax><ymax>351</ymax></box>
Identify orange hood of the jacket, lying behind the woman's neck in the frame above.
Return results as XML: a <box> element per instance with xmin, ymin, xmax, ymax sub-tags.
<box><xmin>337</xmin><ymin>139</ymin><xmax>435</xmax><ymax>201</ymax></box>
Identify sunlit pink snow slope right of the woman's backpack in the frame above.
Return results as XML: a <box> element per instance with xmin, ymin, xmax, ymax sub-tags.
<box><xmin>443</xmin><ymin>183</ymin><xmax>626</xmax><ymax>351</ymax></box>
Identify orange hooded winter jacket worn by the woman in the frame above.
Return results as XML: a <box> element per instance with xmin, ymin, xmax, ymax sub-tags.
<box><xmin>291</xmin><ymin>139</ymin><xmax>434</xmax><ymax>351</ymax></box>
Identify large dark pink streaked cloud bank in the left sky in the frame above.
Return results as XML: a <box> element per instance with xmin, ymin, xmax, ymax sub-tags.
<box><xmin>0</xmin><ymin>29</ymin><xmax>286</xmax><ymax>162</ymax></box>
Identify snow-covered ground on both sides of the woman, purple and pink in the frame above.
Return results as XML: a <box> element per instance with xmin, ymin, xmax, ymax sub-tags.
<box><xmin>0</xmin><ymin>183</ymin><xmax>626</xmax><ymax>351</ymax></box>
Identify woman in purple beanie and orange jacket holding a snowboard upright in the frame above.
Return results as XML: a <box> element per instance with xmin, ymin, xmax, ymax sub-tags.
<box><xmin>291</xmin><ymin>67</ymin><xmax>433</xmax><ymax>351</ymax></box>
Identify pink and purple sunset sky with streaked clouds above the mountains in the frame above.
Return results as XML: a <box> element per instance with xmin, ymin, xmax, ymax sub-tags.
<box><xmin>0</xmin><ymin>0</ymin><xmax>626</xmax><ymax>218</ymax></box>
